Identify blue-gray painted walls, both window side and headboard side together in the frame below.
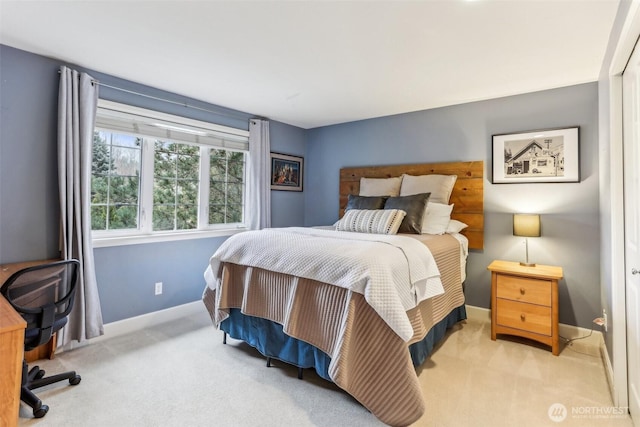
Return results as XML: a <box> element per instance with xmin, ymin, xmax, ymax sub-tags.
<box><xmin>0</xmin><ymin>45</ymin><xmax>600</xmax><ymax>327</ymax></box>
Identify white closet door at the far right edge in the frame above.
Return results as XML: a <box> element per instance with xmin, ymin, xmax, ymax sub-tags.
<box><xmin>622</xmin><ymin>38</ymin><xmax>640</xmax><ymax>427</ymax></box>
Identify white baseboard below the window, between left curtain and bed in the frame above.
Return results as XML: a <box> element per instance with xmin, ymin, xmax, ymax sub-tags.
<box><xmin>61</xmin><ymin>300</ymin><xmax>206</xmax><ymax>353</ymax></box>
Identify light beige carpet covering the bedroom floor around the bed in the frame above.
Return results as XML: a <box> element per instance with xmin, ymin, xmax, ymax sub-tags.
<box><xmin>19</xmin><ymin>308</ymin><xmax>632</xmax><ymax>427</ymax></box>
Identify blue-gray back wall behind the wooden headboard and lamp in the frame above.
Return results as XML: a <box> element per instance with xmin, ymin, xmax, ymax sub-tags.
<box><xmin>305</xmin><ymin>83</ymin><xmax>601</xmax><ymax>328</ymax></box>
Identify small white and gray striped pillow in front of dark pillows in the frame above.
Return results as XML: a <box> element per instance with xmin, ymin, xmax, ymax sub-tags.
<box><xmin>336</xmin><ymin>209</ymin><xmax>406</xmax><ymax>234</ymax></box>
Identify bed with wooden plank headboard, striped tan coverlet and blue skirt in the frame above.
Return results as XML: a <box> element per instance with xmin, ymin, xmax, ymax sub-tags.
<box><xmin>203</xmin><ymin>161</ymin><xmax>484</xmax><ymax>426</ymax></box>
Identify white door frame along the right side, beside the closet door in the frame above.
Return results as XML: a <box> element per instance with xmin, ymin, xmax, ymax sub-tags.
<box><xmin>608</xmin><ymin>1</ymin><xmax>640</xmax><ymax>414</ymax></box>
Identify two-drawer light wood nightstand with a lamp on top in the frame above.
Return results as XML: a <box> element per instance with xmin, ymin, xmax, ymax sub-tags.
<box><xmin>487</xmin><ymin>260</ymin><xmax>562</xmax><ymax>356</ymax></box>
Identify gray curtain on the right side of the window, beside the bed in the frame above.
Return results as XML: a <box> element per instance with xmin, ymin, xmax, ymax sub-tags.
<box><xmin>247</xmin><ymin>119</ymin><xmax>271</xmax><ymax>230</ymax></box>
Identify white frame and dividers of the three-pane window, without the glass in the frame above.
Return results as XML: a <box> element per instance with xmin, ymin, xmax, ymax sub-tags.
<box><xmin>92</xmin><ymin>99</ymin><xmax>250</xmax><ymax>248</ymax></box>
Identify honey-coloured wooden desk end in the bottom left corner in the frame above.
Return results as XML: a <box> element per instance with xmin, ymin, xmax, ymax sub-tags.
<box><xmin>0</xmin><ymin>295</ymin><xmax>27</xmax><ymax>426</ymax></box>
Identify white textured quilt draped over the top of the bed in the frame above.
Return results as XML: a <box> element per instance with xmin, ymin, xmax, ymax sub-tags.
<box><xmin>205</xmin><ymin>227</ymin><xmax>444</xmax><ymax>341</ymax></box>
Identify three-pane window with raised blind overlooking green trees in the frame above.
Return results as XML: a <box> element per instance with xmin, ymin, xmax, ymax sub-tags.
<box><xmin>91</xmin><ymin>100</ymin><xmax>248</xmax><ymax>246</ymax></box>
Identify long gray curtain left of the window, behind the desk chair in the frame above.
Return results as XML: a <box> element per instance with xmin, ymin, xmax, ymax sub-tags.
<box><xmin>58</xmin><ymin>66</ymin><xmax>104</xmax><ymax>345</ymax></box>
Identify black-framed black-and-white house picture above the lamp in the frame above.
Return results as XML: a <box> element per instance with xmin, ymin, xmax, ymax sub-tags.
<box><xmin>492</xmin><ymin>127</ymin><xmax>580</xmax><ymax>184</ymax></box>
